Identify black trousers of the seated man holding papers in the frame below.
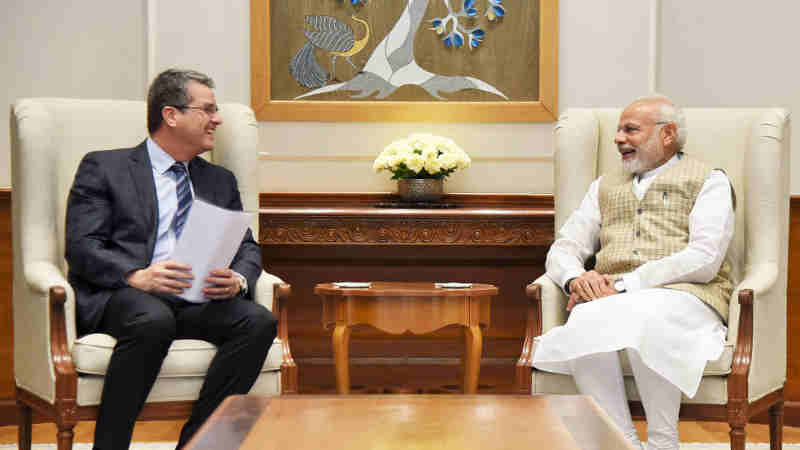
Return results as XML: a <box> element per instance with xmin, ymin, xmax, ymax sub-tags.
<box><xmin>94</xmin><ymin>288</ymin><xmax>277</xmax><ymax>450</ymax></box>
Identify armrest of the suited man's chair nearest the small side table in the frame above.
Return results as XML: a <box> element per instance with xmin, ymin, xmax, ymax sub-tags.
<box><xmin>253</xmin><ymin>271</ymin><xmax>299</xmax><ymax>394</ymax></box>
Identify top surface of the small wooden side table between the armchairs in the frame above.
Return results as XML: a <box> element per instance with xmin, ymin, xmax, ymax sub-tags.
<box><xmin>314</xmin><ymin>281</ymin><xmax>499</xmax><ymax>297</ymax></box>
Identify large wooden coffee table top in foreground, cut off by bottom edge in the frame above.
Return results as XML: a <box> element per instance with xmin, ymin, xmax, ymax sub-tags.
<box><xmin>186</xmin><ymin>395</ymin><xmax>633</xmax><ymax>450</ymax></box>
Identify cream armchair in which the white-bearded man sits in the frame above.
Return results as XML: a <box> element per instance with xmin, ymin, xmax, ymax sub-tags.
<box><xmin>516</xmin><ymin>108</ymin><xmax>791</xmax><ymax>450</ymax></box>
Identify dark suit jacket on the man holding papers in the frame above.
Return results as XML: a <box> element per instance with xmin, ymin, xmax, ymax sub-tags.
<box><xmin>66</xmin><ymin>142</ymin><xmax>261</xmax><ymax>335</ymax></box>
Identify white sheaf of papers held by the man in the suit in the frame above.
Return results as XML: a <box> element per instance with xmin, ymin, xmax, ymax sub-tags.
<box><xmin>170</xmin><ymin>199</ymin><xmax>255</xmax><ymax>303</ymax></box>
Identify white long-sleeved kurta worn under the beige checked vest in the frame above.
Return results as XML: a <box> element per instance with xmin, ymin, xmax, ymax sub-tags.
<box><xmin>533</xmin><ymin>155</ymin><xmax>734</xmax><ymax>397</ymax></box>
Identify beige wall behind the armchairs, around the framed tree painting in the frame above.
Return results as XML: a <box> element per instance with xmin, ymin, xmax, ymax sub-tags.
<box><xmin>0</xmin><ymin>0</ymin><xmax>800</xmax><ymax>193</ymax></box>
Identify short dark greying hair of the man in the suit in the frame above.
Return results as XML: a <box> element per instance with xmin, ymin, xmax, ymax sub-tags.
<box><xmin>147</xmin><ymin>69</ymin><xmax>214</xmax><ymax>134</ymax></box>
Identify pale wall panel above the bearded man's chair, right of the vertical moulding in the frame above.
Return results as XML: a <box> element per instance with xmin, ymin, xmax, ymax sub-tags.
<box><xmin>659</xmin><ymin>0</ymin><xmax>800</xmax><ymax>194</ymax></box>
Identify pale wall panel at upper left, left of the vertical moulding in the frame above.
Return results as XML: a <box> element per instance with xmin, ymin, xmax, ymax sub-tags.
<box><xmin>0</xmin><ymin>0</ymin><xmax>146</xmax><ymax>187</ymax></box>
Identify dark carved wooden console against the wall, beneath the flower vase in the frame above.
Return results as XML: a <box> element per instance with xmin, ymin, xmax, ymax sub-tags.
<box><xmin>259</xmin><ymin>193</ymin><xmax>553</xmax><ymax>393</ymax></box>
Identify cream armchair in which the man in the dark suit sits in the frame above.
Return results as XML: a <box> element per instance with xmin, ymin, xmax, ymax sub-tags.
<box><xmin>11</xmin><ymin>98</ymin><xmax>297</xmax><ymax>450</ymax></box>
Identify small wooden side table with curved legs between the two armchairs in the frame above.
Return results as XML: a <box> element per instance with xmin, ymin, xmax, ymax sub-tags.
<box><xmin>314</xmin><ymin>282</ymin><xmax>498</xmax><ymax>394</ymax></box>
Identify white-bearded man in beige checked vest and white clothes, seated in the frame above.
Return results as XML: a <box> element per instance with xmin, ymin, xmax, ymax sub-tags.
<box><xmin>533</xmin><ymin>96</ymin><xmax>734</xmax><ymax>450</ymax></box>
